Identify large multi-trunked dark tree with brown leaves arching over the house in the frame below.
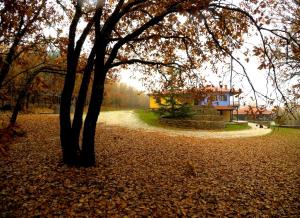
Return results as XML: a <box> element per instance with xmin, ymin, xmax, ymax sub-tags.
<box><xmin>60</xmin><ymin>0</ymin><xmax>300</xmax><ymax>166</ymax></box>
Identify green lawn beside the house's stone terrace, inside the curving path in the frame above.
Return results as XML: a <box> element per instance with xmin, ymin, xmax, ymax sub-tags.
<box><xmin>135</xmin><ymin>109</ymin><xmax>251</xmax><ymax>131</ymax></box>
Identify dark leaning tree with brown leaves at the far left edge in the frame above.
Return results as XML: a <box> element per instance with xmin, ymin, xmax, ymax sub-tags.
<box><xmin>0</xmin><ymin>0</ymin><xmax>62</xmax><ymax>125</ymax></box>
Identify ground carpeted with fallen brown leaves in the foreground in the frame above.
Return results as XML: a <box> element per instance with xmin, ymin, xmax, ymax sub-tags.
<box><xmin>0</xmin><ymin>115</ymin><xmax>300</xmax><ymax>217</ymax></box>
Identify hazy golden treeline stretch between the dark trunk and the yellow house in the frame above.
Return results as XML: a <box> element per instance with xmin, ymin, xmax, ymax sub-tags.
<box><xmin>103</xmin><ymin>82</ymin><xmax>149</xmax><ymax>108</ymax></box>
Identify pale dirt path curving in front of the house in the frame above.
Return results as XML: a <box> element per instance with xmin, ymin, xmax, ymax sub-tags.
<box><xmin>98</xmin><ymin>111</ymin><xmax>272</xmax><ymax>138</ymax></box>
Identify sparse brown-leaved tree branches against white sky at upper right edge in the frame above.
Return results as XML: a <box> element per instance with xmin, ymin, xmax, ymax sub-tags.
<box><xmin>239</xmin><ymin>0</ymin><xmax>300</xmax><ymax>108</ymax></box>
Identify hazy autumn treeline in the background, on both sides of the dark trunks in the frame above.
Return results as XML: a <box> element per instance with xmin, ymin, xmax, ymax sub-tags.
<box><xmin>0</xmin><ymin>74</ymin><xmax>149</xmax><ymax>113</ymax></box>
